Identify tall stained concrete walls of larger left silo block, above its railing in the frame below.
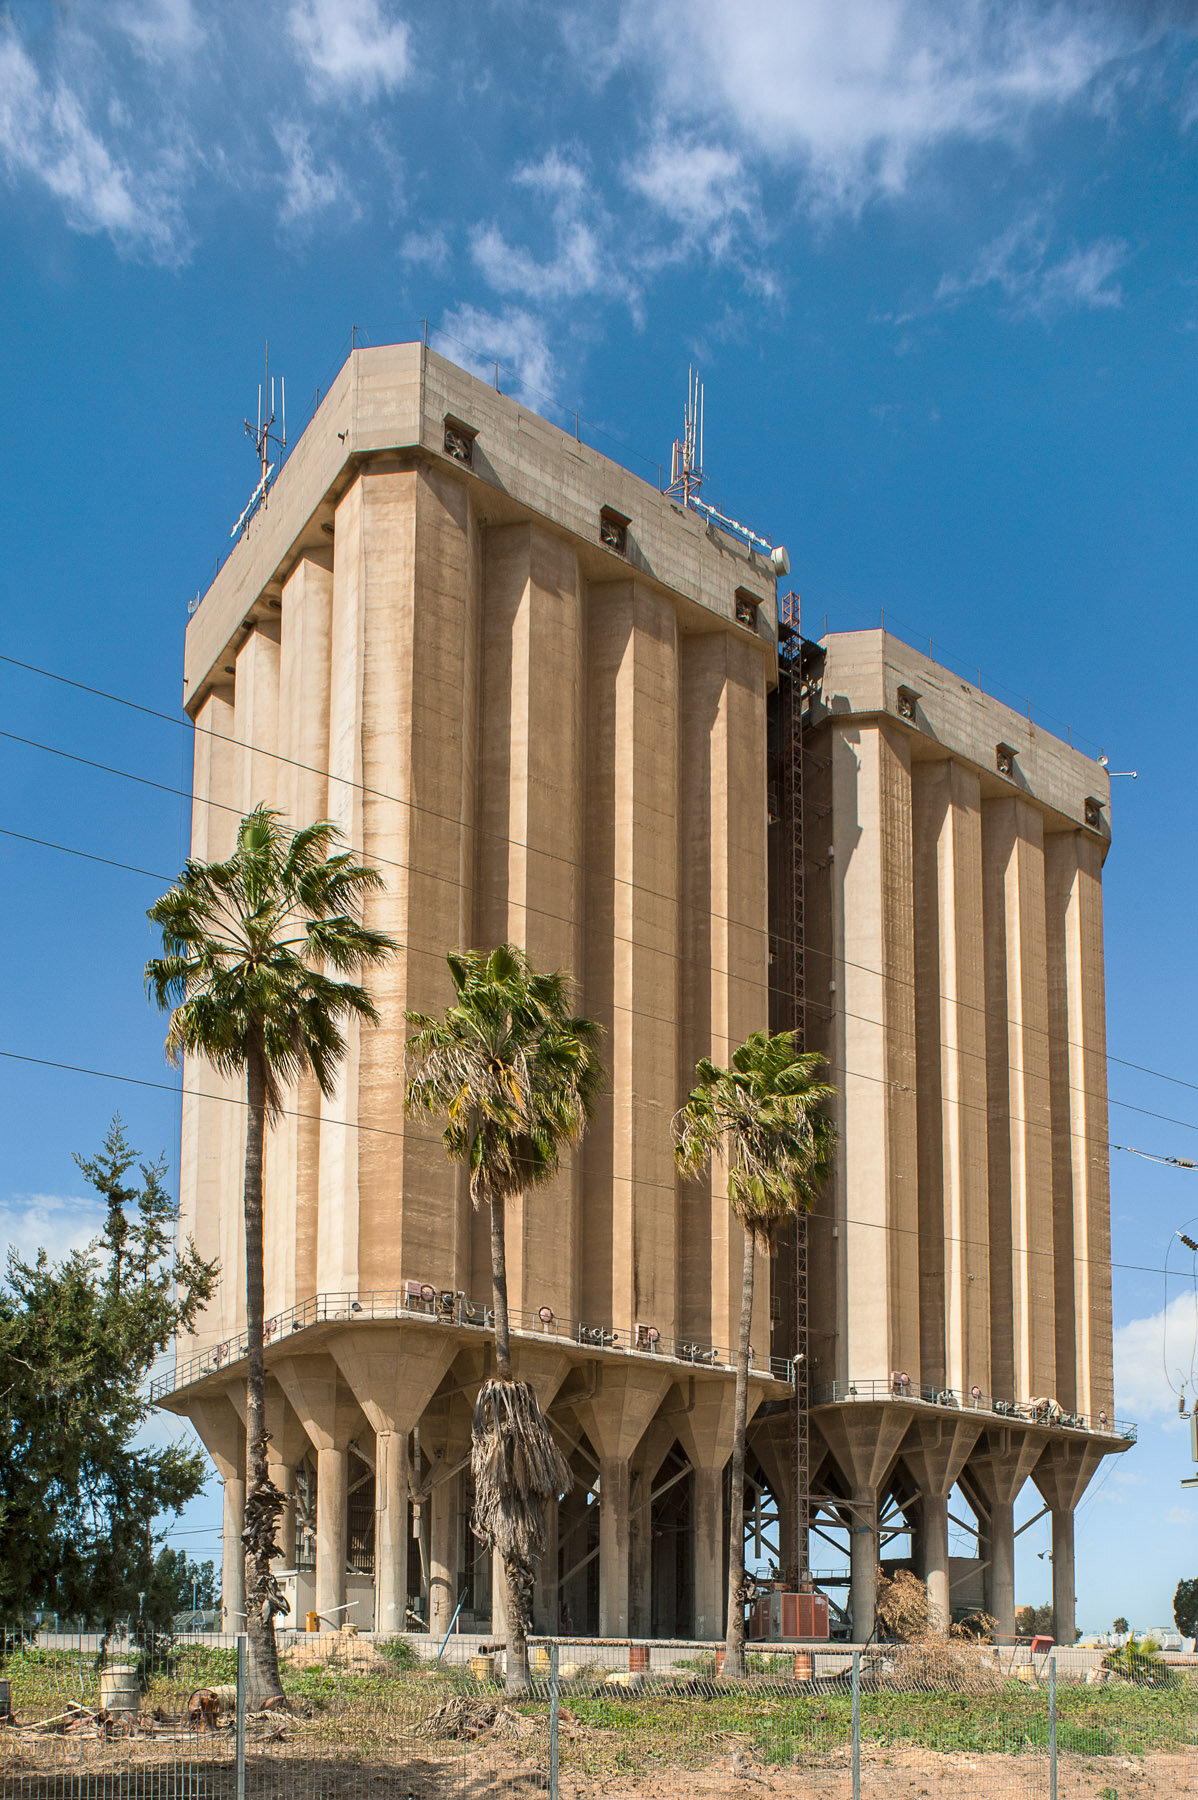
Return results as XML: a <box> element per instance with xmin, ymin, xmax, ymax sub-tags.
<box><xmin>182</xmin><ymin>346</ymin><xmax>775</xmax><ymax>1355</ymax></box>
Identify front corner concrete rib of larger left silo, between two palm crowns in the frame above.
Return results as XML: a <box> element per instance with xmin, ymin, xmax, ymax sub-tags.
<box><xmin>358</xmin><ymin>466</ymin><xmax>477</xmax><ymax>1292</ymax></box>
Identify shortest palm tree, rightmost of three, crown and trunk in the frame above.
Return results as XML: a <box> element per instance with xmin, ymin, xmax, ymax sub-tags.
<box><xmin>675</xmin><ymin>1031</ymin><xmax>836</xmax><ymax>1678</ymax></box>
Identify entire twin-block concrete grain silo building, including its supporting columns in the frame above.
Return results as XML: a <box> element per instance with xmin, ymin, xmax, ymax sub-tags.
<box><xmin>156</xmin><ymin>346</ymin><xmax>1126</xmax><ymax>1638</ymax></box>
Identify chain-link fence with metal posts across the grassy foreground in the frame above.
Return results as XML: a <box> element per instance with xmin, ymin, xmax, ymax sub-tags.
<box><xmin>0</xmin><ymin>1633</ymin><xmax>1198</xmax><ymax>1800</ymax></box>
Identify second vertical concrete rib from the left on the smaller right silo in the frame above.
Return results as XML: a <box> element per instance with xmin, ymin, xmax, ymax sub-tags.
<box><xmin>912</xmin><ymin>761</ymin><xmax>989</xmax><ymax>1393</ymax></box>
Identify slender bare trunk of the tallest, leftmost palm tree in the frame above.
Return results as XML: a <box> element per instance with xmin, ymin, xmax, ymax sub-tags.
<box><xmin>243</xmin><ymin>1042</ymin><xmax>282</xmax><ymax>1706</ymax></box>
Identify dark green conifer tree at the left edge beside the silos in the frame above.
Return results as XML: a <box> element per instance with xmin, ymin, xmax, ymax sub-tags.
<box><xmin>0</xmin><ymin>1118</ymin><xmax>216</xmax><ymax>1633</ymax></box>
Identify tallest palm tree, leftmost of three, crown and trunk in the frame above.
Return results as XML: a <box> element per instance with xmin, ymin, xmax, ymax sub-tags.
<box><xmin>146</xmin><ymin>806</ymin><xmax>394</xmax><ymax>1703</ymax></box>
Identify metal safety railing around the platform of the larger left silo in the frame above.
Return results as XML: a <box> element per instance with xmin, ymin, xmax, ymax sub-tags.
<box><xmin>149</xmin><ymin>1282</ymin><xmax>793</xmax><ymax>1400</ymax></box>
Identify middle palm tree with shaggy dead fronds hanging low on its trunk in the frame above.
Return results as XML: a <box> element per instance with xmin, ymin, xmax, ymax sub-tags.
<box><xmin>407</xmin><ymin>943</ymin><xmax>603</xmax><ymax>1694</ymax></box>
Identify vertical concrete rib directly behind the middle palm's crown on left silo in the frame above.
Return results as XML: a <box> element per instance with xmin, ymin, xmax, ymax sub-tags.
<box><xmin>473</xmin><ymin>524</ymin><xmax>583</xmax><ymax>1319</ymax></box>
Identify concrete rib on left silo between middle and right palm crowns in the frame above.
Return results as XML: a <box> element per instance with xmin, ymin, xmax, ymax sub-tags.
<box><xmin>581</xmin><ymin>581</ymin><xmax>678</xmax><ymax>1337</ymax></box>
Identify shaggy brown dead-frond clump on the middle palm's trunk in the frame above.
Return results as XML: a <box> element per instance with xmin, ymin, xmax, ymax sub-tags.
<box><xmin>469</xmin><ymin>1381</ymin><xmax>574</xmax><ymax>1564</ymax></box>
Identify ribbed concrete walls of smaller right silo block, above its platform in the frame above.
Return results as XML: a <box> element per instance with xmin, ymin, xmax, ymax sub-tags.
<box><xmin>806</xmin><ymin>632</ymin><xmax>1112</xmax><ymax>1417</ymax></box>
